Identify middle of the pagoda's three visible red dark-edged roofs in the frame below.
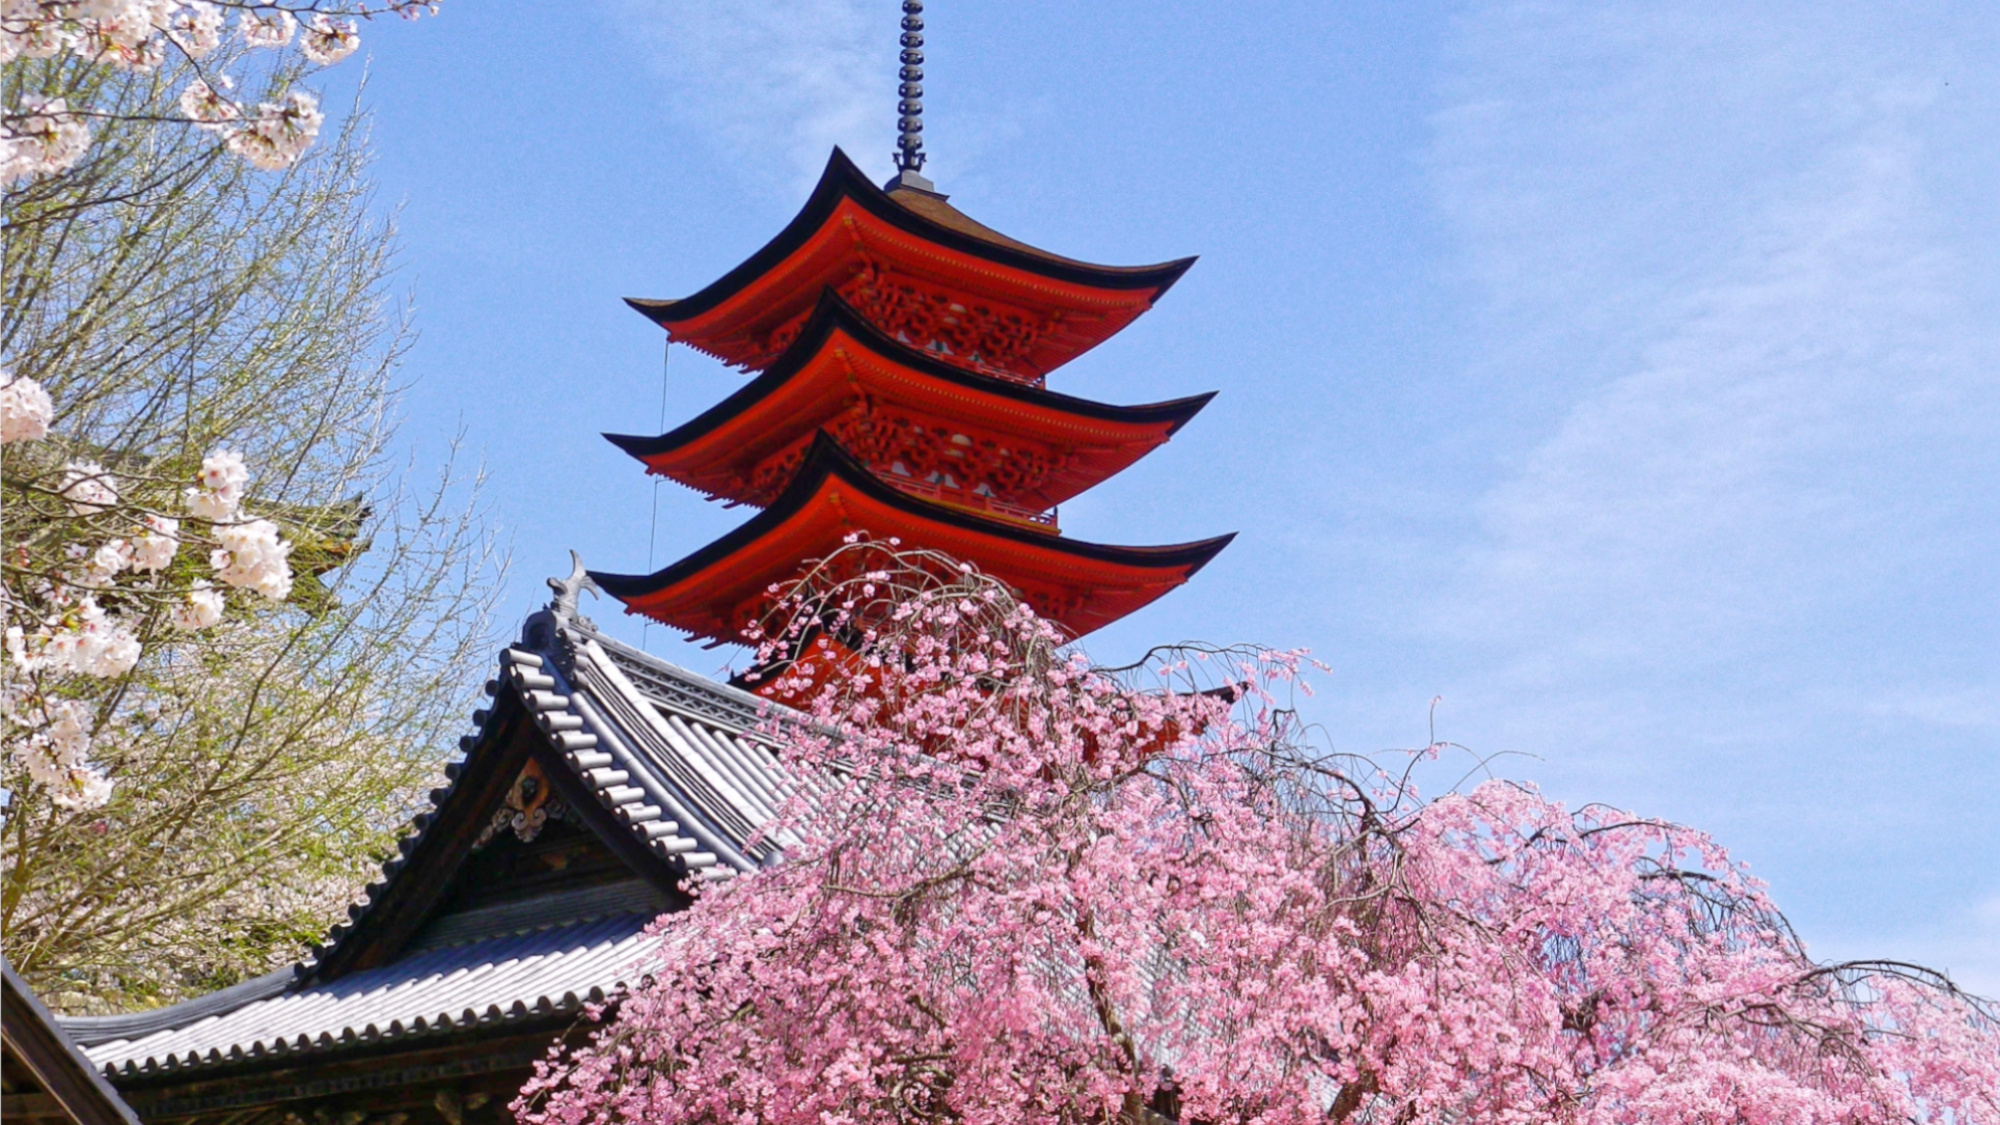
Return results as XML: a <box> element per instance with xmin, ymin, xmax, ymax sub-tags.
<box><xmin>604</xmin><ymin>290</ymin><xmax>1214</xmax><ymax>508</ymax></box>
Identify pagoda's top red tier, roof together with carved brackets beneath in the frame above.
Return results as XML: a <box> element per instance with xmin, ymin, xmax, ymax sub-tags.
<box><xmin>630</xmin><ymin>148</ymin><xmax>1194</xmax><ymax>382</ymax></box>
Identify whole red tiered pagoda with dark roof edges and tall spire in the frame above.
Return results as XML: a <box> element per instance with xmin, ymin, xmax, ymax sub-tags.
<box><xmin>592</xmin><ymin>0</ymin><xmax>1232</xmax><ymax>643</ymax></box>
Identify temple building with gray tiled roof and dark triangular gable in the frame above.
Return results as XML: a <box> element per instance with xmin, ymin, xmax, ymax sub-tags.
<box><xmin>56</xmin><ymin>588</ymin><xmax>786</xmax><ymax>1125</ymax></box>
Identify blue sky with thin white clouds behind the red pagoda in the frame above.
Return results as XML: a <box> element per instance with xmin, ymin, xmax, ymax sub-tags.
<box><xmin>320</xmin><ymin>0</ymin><xmax>2000</xmax><ymax>980</ymax></box>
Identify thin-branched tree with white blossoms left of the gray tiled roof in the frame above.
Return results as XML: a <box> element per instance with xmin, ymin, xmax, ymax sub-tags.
<box><xmin>0</xmin><ymin>70</ymin><xmax>498</xmax><ymax>1013</ymax></box>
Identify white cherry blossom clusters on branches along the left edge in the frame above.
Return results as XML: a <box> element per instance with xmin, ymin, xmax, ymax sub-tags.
<box><xmin>0</xmin><ymin>0</ymin><xmax>436</xmax><ymax>832</ymax></box>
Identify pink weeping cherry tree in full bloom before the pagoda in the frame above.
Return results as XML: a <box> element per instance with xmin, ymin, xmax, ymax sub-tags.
<box><xmin>514</xmin><ymin>540</ymin><xmax>2000</xmax><ymax>1125</ymax></box>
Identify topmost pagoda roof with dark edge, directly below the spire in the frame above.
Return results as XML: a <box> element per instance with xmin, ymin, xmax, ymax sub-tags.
<box><xmin>626</xmin><ymin>148</ymin><xmax>1194</xmax><ymax>378</ymax></box>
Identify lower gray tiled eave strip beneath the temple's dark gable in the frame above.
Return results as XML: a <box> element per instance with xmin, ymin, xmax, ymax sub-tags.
<box><xmin>66</xmin><ymin>913</ymin><xmax>658</xmax><ymax>1075</ymax></box>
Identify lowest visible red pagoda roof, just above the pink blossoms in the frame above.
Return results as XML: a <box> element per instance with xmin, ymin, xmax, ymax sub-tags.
<box><xmin>590</xmin><ymin>430</ymin><xmax>1234</xmax><ymax>645</ymax></box>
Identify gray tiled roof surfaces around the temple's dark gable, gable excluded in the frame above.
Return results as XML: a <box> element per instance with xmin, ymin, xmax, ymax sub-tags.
<box><xmin>64</xmin><ymin>596</ymin><xmax>788</xmax><ymax>1075</ymax></box>
